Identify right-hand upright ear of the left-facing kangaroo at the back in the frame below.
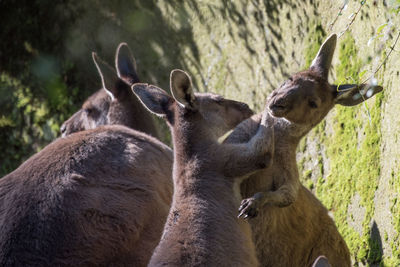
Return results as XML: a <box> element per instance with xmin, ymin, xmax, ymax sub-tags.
<box><xmin>115</xmin><ymin>43</ymin><xmax>140</xmax><ymax>85</ymax></box>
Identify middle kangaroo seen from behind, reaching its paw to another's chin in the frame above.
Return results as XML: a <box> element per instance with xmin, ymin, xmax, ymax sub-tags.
<box><xmin>132</xmin><ymin>70</ymin><xmax>273</xmax><ymax>266</ymax></box>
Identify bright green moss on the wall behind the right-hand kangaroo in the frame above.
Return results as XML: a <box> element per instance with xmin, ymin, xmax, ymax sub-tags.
<box><xmin>314</xmin><ymin>34</ymin><xmax>383</xmax><ymax>264</ymax></box>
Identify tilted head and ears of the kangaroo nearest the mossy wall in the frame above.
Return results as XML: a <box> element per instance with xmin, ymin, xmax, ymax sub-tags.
<box><xmin>268</xmin><ymin>34</ymin><xmax>382</xmax><ymax>127</ymax></box>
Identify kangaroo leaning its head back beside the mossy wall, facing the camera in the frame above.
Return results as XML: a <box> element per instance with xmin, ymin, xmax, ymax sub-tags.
<box><xmin>225</xmin><ymin>34</ymin><xmax>382</xmax><ymax>267</ymax></box>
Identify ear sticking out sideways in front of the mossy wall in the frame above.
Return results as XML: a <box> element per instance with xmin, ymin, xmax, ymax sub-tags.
<box><xmin>332</xmin><ymin>84</ymin><xmax>383</xmax><ymax>106</ymax></box>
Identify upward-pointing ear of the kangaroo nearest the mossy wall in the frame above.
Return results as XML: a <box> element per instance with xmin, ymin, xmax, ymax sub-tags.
<box><xmin>310</xmin><ymin>34</ymin><xmax>337</xmax><ymax>78</ymax></box>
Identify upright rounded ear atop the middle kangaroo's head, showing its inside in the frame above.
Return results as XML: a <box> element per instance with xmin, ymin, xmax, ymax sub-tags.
<box><xmin>170</xmin><ymin>69</ymin><xmax>196</xmax><ymax>110</ymax></box>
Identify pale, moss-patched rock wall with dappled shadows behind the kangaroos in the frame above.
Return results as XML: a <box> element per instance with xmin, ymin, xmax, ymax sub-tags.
<box><xmin>0</xmin><ymin>0</ymin><xmax>400</xmax><ymax>266</ymax></box>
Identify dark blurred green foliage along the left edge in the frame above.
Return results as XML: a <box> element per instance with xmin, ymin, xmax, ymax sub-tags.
<box><xmin>0</xmin><ymin>1</ymin><xmax>86</xmax><ymax>177</ymax></box>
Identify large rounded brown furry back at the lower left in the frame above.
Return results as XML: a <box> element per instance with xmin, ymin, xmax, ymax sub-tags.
<box><xmin>0</xmin><ymin>125</ymin><xmax>173</xmax><ymax>266</ymax></box>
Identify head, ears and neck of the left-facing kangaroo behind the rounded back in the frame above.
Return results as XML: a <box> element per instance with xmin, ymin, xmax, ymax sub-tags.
<box><xmin>60</xmin><ymin>43</ymin><xmax>160</xmax><ymax>138</ymax></box>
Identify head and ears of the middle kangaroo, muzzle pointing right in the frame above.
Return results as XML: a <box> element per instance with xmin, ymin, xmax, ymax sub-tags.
<box><xmin>132</xmin><ymin>70</ymin><xmax>253</xmax><ymax>138</ymax></box>
